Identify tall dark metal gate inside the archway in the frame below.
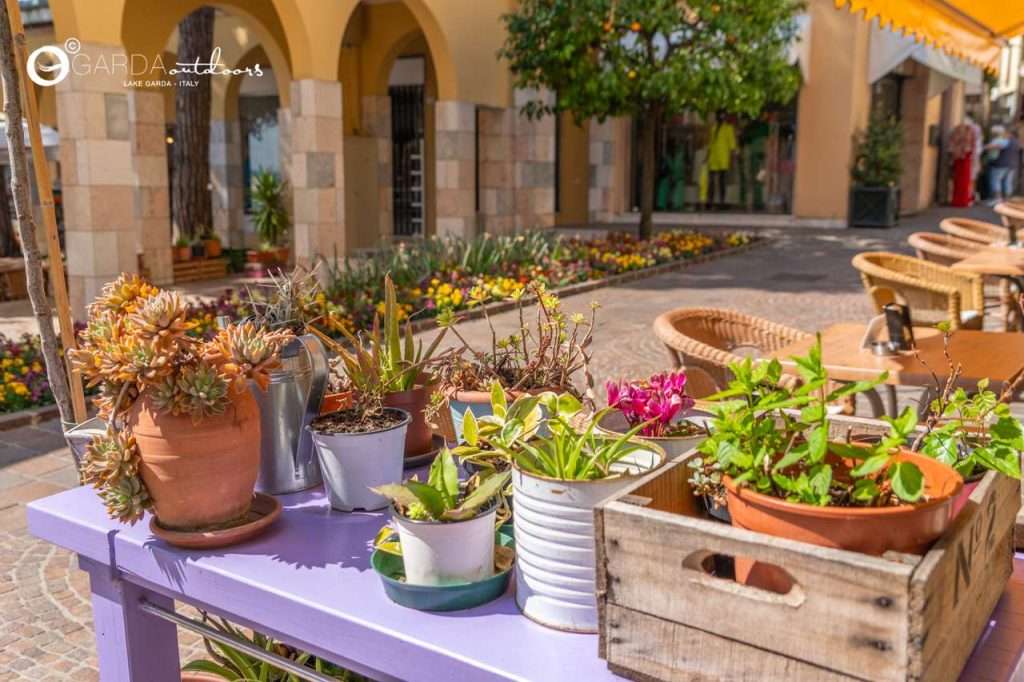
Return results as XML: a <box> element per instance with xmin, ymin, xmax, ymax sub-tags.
<box><xmin>388</xmin><ymin>85</ymin><xmax>424</xmax><ymax>237</ymax></box>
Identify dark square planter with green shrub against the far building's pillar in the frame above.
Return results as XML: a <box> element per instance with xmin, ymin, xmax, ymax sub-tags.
<box><xmin>850</xmin><ymin>116</ymin><xmax>903</xmax><ymax>227</ymax></box>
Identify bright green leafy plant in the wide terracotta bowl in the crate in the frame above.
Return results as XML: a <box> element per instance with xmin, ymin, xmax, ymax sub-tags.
<box><xmin>694</xmin><ymin>338</ymin><xmax>924</xmax><ymax>506</ymax></box>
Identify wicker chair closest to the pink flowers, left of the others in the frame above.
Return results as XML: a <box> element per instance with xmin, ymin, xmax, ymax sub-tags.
<box><xmin>654</xmin><ymin>308</ymin><xmax>811</xmax><ymax>397</ymax></box>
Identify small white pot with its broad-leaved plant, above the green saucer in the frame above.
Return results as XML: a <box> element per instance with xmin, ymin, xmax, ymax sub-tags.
<box><xmin>374</xmin><ymin>449</ymin><xmax>509</xmax><ymax>586</ymax></box>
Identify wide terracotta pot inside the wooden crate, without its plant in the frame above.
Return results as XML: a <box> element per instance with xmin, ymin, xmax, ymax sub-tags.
<box><xmin>722</xmin><ymin>450</ymin><xmax>964</xmax><ymax>593</ymax></box>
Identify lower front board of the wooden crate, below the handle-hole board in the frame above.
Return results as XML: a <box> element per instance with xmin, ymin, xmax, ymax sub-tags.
<box><xmin>607</xmin><ymin>603</ymin><xmax>863</xmax><ymax>682</ymax></box>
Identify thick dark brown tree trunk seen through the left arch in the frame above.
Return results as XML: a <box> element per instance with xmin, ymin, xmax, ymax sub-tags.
<box><xmin>171</xmin><ymin>7</ymin><xmax>213</xmax><ymax>238</ymax></box>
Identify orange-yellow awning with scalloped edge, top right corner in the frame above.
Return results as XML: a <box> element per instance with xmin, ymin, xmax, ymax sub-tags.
<box><xmin>835</xmin><ymin>0</ymin><xmax>1024</xmax><ymax>70</ymax></box>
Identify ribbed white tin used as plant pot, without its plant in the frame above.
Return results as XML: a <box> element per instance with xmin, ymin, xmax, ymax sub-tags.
<box><xmin>512</xmin><ymin>443</ymin><xmax>666</xmax><ymax>633</ymax></box>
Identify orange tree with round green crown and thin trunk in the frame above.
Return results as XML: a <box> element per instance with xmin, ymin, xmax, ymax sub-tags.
<box><xmin>500</xmin><ymin>0</ymin><xmax>803</xmax><ymax>238</ymax></box>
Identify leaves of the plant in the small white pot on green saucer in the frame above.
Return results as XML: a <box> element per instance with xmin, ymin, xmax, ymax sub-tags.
<box><xmin>373</xmin><ymin>447</ymin><xmax>511</xmax><ymax>521</ymax></box>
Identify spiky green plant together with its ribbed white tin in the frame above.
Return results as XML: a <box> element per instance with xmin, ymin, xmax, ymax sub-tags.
<box><xmin>461</xmin><ymin>390</ymin><xmax>665</xmax><ymax>632</ymax></box>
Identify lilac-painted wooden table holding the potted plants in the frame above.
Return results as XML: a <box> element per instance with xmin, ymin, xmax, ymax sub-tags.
<box><xmin>28</xmin><ymin>487</ymin><xmax>1024</xmax><ymax>682</ymax></box>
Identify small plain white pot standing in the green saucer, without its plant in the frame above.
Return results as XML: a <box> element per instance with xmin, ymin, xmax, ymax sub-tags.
<box><xmin>391</xmin><ymin>505</ymin><xmax>498</xmax><ymax>585</ymax></box>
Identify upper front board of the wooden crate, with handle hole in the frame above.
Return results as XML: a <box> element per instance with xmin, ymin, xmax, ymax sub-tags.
<box><xmin>603</xmin><ymin>491</ymin><xmax>913</xmax><ymax>680</ymax></box>
